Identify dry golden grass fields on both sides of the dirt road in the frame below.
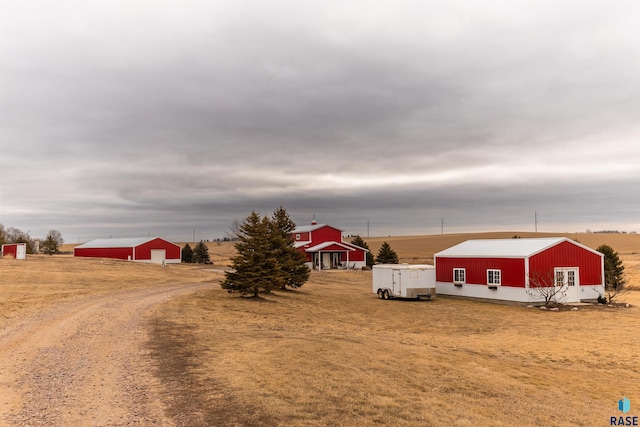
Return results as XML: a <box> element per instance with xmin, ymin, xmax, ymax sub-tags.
<box><xmin>5</xmin><ymin>233</ymin><xmax>640</xmax><ymax>426</ymax></box>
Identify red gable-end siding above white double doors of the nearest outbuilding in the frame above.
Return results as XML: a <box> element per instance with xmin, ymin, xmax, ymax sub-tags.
<box><xmin>529</xmin><ymin>242</ymin><xmax>603</xmax><ymax>285</ymax></box>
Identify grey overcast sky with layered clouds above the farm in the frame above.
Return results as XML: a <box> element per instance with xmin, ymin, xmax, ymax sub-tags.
<box><xmin>0</xmin><ymin>0</ymin><xmax>640</xmax><ymax>243</ymax></box>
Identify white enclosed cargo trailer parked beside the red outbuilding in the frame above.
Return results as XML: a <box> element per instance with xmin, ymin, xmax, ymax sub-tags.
<box><xmin>373</xmin><ymin>264</ymin><xmax>436</xmax><ymax>299</ymax></box>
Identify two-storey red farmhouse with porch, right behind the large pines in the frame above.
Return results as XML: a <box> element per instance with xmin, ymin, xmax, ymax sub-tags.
<box><xmin>291</xmin><ymin>220</ymin><xmax>369</xmax><ymax>270</ymax></box>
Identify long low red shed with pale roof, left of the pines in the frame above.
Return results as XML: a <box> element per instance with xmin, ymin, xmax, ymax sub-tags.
<box><xmin>73</xmin><ymin>237</ymin><xmax>182</xmax><ymax>264</ymax></box>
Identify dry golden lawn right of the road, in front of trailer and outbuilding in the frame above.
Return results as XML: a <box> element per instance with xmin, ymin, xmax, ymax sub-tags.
<box><xmin>151</xmin><ymin>271</ymin><xmax>640</xmax><ymax>426</ymax></box>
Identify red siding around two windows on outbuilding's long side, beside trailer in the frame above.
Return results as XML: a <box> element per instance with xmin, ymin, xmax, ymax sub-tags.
<box><xmin>436</xmin><ymin>257</ymin><xmax>525</xmax><ymax>288</ymax></box>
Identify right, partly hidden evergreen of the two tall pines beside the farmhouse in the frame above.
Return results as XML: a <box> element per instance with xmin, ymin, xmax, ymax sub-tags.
<box><xmin>271</xmin><ymin>206</ymin><xmax>310</xmax><ymax>289</ymax></box>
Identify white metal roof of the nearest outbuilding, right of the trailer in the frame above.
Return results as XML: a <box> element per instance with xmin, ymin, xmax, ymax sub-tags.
<box><xmin>435</xmin><ymin>237</ymin><xmax>568</xmax><ymax>258</ymax></box>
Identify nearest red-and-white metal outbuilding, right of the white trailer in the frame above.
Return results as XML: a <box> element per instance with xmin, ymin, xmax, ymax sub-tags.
<box><xmin>434</xmin><ymin>237</ymin><xmax>604</xmax><ymax>302</ymax></box>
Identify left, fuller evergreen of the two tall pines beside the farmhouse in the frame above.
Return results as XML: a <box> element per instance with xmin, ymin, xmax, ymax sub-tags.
<box><xmin>221</xmin><ymin>211</ymin><xmax>285</xmax><ymax>297</ymax></box>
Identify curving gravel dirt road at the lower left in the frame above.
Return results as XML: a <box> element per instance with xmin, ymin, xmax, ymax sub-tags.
<box><xmin>0</xmin><ymin>283</ymin><xmax>215</xmax><ymax>426</ymax></box>
